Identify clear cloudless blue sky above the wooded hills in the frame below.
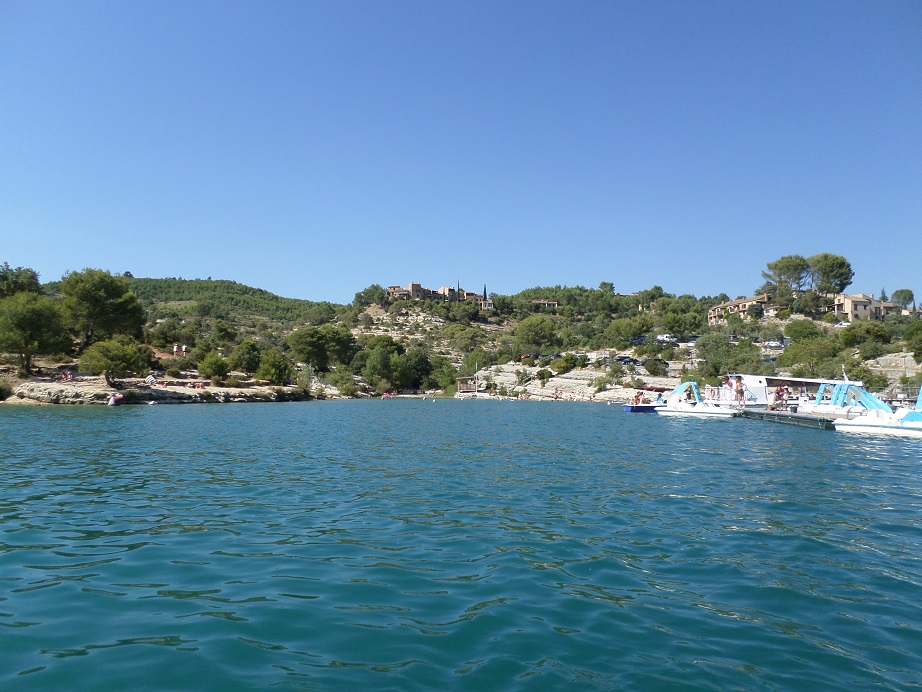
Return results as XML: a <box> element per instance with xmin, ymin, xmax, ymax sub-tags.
<box><xmin>0</xmin><ymin>0</ymin><xmax>922</xmax><ymax>303</ymax></box>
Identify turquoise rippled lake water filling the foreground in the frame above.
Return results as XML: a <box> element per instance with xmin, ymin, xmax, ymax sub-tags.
<box><xmin>0</xmin><ymin>400</ymin><xmax>922</xmax><ymax>690</ymax></box>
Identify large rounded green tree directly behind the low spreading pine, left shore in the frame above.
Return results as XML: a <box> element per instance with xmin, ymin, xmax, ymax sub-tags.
<box><xmin>61</xmin><ymin>269</ymin><xmax>145</xmax><ymax>348</ymax></box>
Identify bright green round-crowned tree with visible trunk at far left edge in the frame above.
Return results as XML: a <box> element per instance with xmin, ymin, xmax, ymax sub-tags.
<box><xmin>0</xmin><ymin>291</ymin><xmax>70</xmax><ymax>375</ymax></box>
